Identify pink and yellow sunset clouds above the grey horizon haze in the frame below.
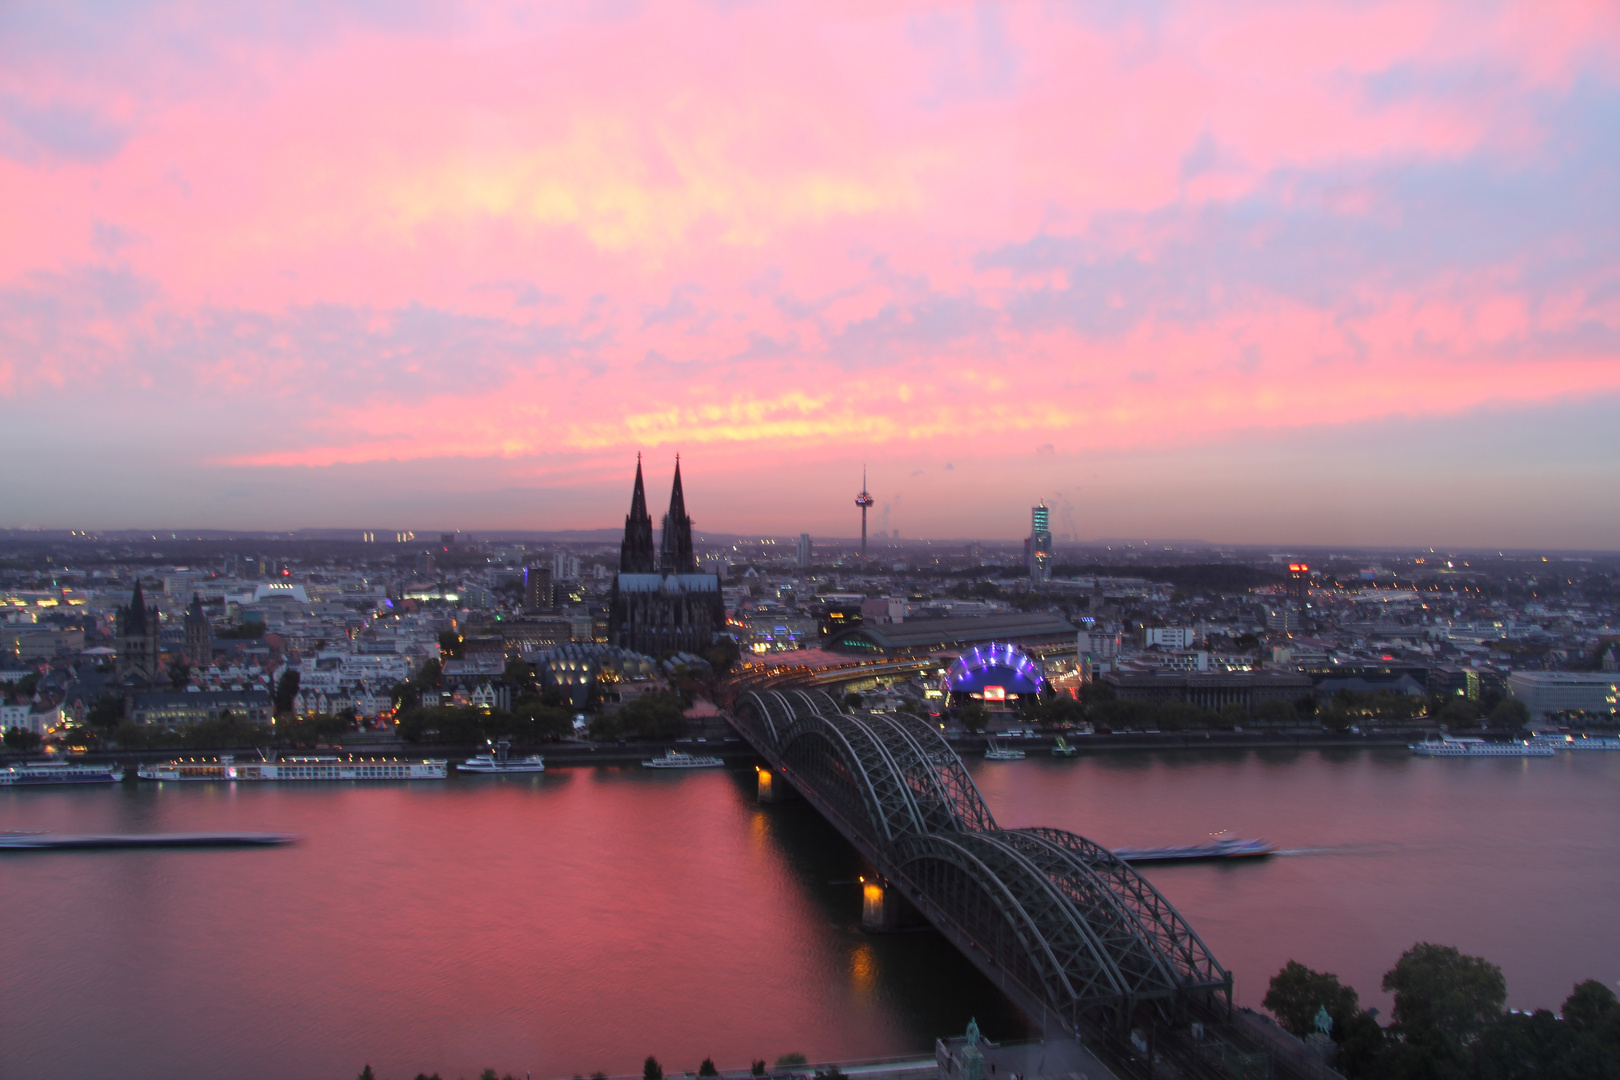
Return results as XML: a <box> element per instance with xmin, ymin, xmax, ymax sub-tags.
<box><xmin>0</xmin><ymin>2</ymin><xmax>1620</xmax><ymax>540</ymax></box>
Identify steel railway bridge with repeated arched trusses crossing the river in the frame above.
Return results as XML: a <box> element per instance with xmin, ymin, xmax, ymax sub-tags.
<box><xmin>729</xmin><ymin>690</ymin><xmax>1231</xmax><ymax>1031</ymax></box>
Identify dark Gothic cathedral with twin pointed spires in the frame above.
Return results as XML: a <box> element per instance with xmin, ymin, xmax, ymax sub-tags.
<box><xmin>608</xmin><ymin>457</ymin><xmax>726</xmax><ymax>657</ymax></box>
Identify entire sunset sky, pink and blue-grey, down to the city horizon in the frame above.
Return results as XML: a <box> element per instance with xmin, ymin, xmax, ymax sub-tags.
<box><xmin>0</xmin><ymin>0</ymin><xmax>1620</xmax><ymax>549</ymax></box>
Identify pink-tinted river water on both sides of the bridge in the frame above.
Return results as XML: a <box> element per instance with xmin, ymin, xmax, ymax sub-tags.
<box><xmin>0</xmin><ymin>750</ymin><xmax>1620</xmax><ymax>1080</ymax></box>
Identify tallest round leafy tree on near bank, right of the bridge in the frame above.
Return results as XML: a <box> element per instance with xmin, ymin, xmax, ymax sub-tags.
<box><xmin>1383</xmin><ymin>941</ymin><xmax>1508</xmax><ymax>1046</ymax></box>
